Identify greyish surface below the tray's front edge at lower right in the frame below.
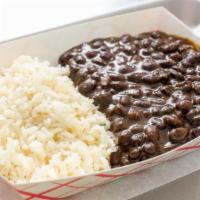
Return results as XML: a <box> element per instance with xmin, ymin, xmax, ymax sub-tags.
<box><xmin>66</xmin><ymin>151</ymin><xmax>200</xmax><ymax>200</ymax></box>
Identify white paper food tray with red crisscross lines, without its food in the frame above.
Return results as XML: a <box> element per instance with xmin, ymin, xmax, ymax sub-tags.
<box><xmin>0</xmin><ymin>8</ymin><xmax>200</xmax><ymax>200</ymax></box>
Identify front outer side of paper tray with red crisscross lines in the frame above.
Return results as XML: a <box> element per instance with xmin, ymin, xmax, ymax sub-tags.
<box><xmin>2</xmin><ymin>138</ymin><xmax>200</xmax><ymax>200</ymax></box>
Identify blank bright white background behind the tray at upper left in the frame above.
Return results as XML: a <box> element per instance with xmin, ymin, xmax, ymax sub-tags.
<box><xmin>0</xmin><ymin>0</ymin><xmax>143</xmax><ymax>41</ymax></box>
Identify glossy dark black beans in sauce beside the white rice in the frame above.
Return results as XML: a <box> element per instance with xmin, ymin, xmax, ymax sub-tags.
<box><xmin>59</xmin><ymin>31</ymin><xmax>200</xmax><ymax>167</ymax></box>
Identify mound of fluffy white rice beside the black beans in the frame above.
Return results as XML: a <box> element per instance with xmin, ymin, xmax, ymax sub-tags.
<box><xmin>0</xmin><ymin>56</ymin><xmax>115</xmax><ymax>183</ymax></box>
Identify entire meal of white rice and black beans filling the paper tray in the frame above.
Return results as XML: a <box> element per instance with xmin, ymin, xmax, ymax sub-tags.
<box><xmin>0</xmin><ymin>31</ymin><xmax>200</xmax><ymax>183</ymax></box>
